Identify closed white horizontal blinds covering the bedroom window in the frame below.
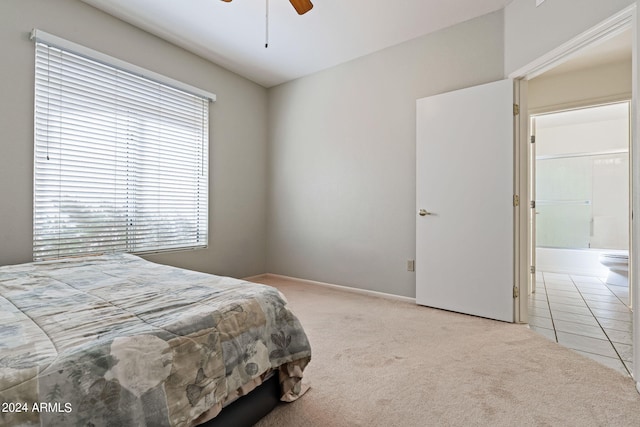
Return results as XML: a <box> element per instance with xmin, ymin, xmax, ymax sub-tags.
<box><xmin>33</xmin><ymin>31</ymin><xmax>209</xmax><ymax>260</ymax></box>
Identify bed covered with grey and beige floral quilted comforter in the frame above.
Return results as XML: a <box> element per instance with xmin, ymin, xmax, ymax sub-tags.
<box><xmin>0</xmin><ymin>254</ymin><xmax>311</xmax><ymax>427</ymax></box>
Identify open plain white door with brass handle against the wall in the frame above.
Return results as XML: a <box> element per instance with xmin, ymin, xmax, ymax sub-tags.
<box><xmin>416</xmin><ymin>80</ymin><xmax>514</xmax><ymax>322</ymax></box>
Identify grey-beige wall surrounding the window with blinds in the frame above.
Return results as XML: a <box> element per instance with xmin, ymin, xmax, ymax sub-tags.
<box><xmin>0</xmin><ymin>0</ymin><xmax>267</xmax><ymax>276</ymax></box>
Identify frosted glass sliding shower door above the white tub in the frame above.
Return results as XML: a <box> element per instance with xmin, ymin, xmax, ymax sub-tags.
<box><xmin>536</xmin><ymin>152</ymin><xmax>629</xmax><ymax>249</ymax></box>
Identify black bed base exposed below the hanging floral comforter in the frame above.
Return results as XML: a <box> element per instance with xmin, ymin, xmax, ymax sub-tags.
<box><xmin>199</xmin><ymin>373</ymin><xmax>280</xmax><ymax>427</ymax></box>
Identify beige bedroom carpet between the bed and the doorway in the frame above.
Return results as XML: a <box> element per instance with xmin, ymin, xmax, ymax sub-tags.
<box><xmin>251</xmin><ymin>276</ymin><xmax>640</xmax><ymax>427</ymax></box>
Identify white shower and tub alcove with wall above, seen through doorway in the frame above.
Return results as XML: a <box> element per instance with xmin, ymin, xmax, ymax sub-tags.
<box><xmin>532</xmin><ymin>102</ymin><xmax>629</xmax><ymax>274</ymax></box>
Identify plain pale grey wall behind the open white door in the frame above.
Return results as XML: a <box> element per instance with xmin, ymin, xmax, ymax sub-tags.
<box><xmin>267</xmin><ymin>11</ymin><xmax>503</xmax><ymax>297</ymax></box>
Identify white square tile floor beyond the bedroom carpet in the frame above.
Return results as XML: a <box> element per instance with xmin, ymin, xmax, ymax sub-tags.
<box><xmin>529</xmin><ymin>272</ymin><xmax>633</xmax><ymax>375</ymax></box>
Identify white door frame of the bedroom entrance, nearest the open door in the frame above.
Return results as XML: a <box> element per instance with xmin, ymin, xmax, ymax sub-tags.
<box><xmin>509</xmin><ymin>3</ymin><xmax>640</xmax><ymax>391</ymax></box>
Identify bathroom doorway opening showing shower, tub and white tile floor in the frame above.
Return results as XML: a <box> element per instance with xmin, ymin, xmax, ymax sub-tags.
<box><xmin>529</xmin><ymin>101</ymin><xmax>633</xmax><ymax>375</ymax></box>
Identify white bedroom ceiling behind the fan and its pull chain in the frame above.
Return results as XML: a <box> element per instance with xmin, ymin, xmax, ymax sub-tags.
<box><xmin>82</xmin><ymin>0</ymin><xmax>510</xmax><ymax>87</ymax></box>
